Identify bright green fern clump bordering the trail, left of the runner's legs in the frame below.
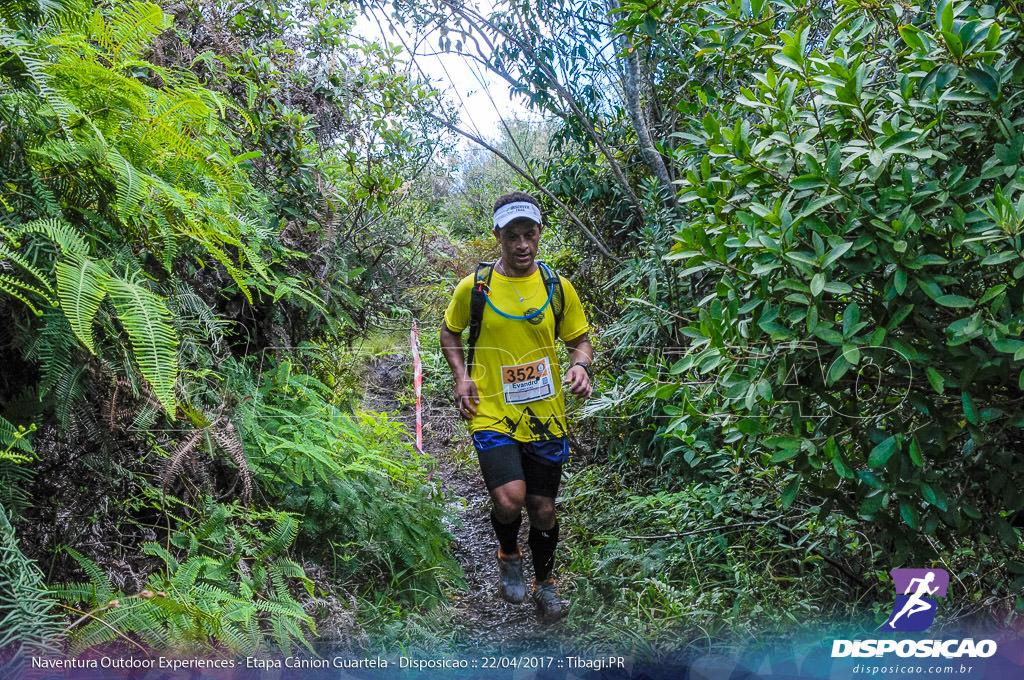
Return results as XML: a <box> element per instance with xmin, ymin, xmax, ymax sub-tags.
<box><xmin>241</xmin><ymin>360</ymin><xmax>461</xmax><ymax>603</ymax></box>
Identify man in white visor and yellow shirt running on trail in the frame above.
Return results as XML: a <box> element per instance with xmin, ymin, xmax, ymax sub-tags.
<box><xmin>440</xmin><ymin>192</ymin><xmax>594</xmax><ymax>621</ymax></box>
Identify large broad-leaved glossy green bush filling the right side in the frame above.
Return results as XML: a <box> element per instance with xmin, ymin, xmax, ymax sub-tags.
<box><xmin>598</xmin><ymin>1</ymin><xmax>1024</xmax><ymax>573</ymax></box>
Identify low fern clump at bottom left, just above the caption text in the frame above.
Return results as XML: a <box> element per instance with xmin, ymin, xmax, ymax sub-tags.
<box><xmin>52</xmin><ymin>505</ymin><xmax>315</xmax><ymax>654</ymax></box>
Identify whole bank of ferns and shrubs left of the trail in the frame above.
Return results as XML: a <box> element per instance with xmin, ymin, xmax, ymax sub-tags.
<box><xmin>0</xmin><ymin>1</ymin><xmax>459</xmax><ymax>661</ymax></box>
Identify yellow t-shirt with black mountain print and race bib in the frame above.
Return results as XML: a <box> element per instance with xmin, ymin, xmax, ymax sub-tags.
<box><xmin>444</xmin><ymin>268</ymin><xmax>589</xmax><ymax>441</ymax></box>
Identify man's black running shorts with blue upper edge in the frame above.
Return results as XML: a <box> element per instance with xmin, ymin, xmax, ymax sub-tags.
<box><xmin>473</xmin><ymin>430</ymin><xmax>569</xmax><ymax>498</ymax></box>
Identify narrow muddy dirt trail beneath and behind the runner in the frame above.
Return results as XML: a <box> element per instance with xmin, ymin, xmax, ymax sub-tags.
<box><xmin>364</xmin><ymin>354</ymin><xmax>562</xmax><ymax>652</ymax></box>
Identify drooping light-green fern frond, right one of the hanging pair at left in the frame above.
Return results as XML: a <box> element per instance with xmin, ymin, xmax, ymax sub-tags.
<box><xmin>110</xmin><ymin>277</ymin><xmax>178</xmax><ymax>413</ymax></box>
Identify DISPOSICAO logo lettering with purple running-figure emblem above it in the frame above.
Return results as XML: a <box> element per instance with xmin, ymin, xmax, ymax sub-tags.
<box><xmin>831</xmin><ymin>568</ymin><xmax>996</xmax><ymax>658</ymax></box>
